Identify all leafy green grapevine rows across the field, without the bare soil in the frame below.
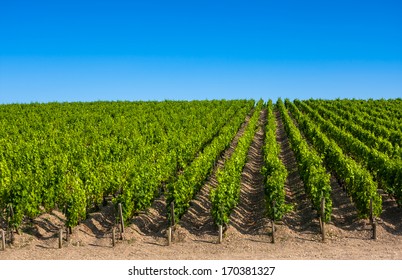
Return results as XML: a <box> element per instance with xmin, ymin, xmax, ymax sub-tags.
<box><xmin>0</xmin><ymin>99</ymin><xmax>402</xmax><ymax>234</ymax></box>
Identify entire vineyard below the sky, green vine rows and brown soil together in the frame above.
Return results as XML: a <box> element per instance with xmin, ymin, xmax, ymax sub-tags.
<box><xmin>0</xmin><ymin>99</ymin><xmax>402</xmax><ymax>259</ymax></box>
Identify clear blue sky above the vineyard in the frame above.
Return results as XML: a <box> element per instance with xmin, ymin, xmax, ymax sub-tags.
<box><xmin>0</xmin><ymin>0</ymin><xmax>402</xmax><ymax>103</ymax></box>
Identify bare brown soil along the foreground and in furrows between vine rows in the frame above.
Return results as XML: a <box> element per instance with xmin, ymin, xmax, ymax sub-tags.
<box><xmin>0</xmin><ymin>110</ymin><xmax>402</xmax><ymax>260</ymax></box>
